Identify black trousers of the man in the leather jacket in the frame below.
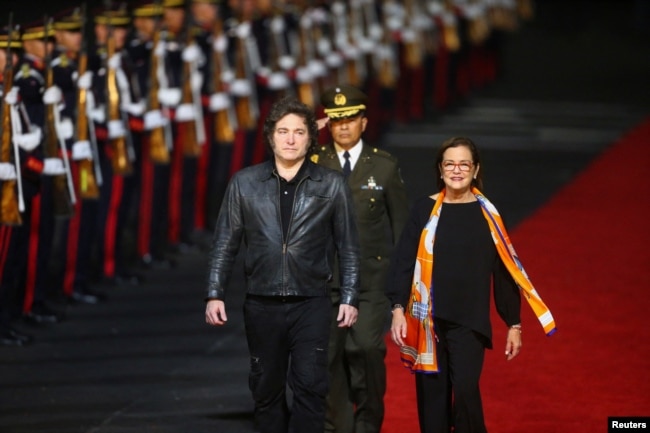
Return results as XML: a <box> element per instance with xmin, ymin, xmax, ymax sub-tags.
<box><xmin>244</xmin><ymin>296</ymin><xmax>331</xmax><ymax>433</ymax></box>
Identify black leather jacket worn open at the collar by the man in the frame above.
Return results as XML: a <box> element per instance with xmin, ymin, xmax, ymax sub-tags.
<box><xmin>206</xmin><ymin>159</ymin><xmax>359</xmax><ymax>307</ymax></box>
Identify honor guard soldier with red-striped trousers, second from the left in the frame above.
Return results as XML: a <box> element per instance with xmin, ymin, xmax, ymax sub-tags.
<box><xmin>14</xmin><ymin>20</ymin><xmax>73</xmax><ymax>324</ymax></box>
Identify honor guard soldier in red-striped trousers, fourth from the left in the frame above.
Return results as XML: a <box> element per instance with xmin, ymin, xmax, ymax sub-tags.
<box><xmin>91</xmin><ymin>5</ymin><xmax>145</xmax><ymax>284</ymax></box>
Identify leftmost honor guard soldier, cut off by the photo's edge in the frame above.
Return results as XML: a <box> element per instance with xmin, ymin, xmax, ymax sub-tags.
<box><xmin>0</xmin><ymin>24</ymin><xmax>35</xmax><ymax>346</ymax></box>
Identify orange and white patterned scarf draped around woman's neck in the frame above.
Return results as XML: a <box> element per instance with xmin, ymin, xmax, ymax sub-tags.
<box><xmin>400</xmin><ymin>188</ymin><xmax>556</xmax><ymax>373</ymax></box>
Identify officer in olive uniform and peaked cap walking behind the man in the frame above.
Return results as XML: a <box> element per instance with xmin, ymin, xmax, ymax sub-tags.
<box><xmin>312</xmin><ymin>85</ymin><xmax>409</xmax><ymax>433</ymax></box>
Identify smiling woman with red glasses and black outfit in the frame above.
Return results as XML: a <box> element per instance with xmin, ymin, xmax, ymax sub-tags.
<box><xmin>387</xmin><ymin>137</ymin><xmax>521</xmax><ymax>433</ymax></box>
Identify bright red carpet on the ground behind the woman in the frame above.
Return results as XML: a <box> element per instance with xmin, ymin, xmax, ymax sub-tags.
<box><xmin>382</xmin><ymin>119</ymin><xmax>650</xmax><ymax>433</ymax></box>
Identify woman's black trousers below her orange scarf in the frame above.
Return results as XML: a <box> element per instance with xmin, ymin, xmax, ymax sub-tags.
<box><xmin>415</xmin><ymin>319</ymin><xmax>487</xmax><ymax>433</ymax></box>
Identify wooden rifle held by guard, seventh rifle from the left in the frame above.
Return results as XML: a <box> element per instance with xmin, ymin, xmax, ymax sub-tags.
<box><xmin>210</xmin><ymin>8</ymin><xmax>237</xmax><ymax>143</ymax></box>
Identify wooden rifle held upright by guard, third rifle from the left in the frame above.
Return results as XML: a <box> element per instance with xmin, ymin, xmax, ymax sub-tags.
<box><xmin>76</xmin><ymin>3</ymin><xmax>102</xmax><ymax>199</ymax></box>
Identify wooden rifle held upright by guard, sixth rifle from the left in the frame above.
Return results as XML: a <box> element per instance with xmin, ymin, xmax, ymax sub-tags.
<box><xmin>177</xmin><ymin>1</ymin><xmax>205</xmax><ymax>156</ymax></box>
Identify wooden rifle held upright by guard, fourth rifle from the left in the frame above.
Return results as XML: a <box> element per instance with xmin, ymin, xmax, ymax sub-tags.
<box><xmin>105</xmin><ymin>0</ymin><xmax>133</xmax><ymax>176</ymax></box>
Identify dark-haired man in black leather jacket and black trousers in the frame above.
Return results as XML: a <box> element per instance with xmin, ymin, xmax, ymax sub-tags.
<box><xmin>206</xmin><ymin>98</ymin><xmax>359</xmax><ymax>433</ymax></box>
